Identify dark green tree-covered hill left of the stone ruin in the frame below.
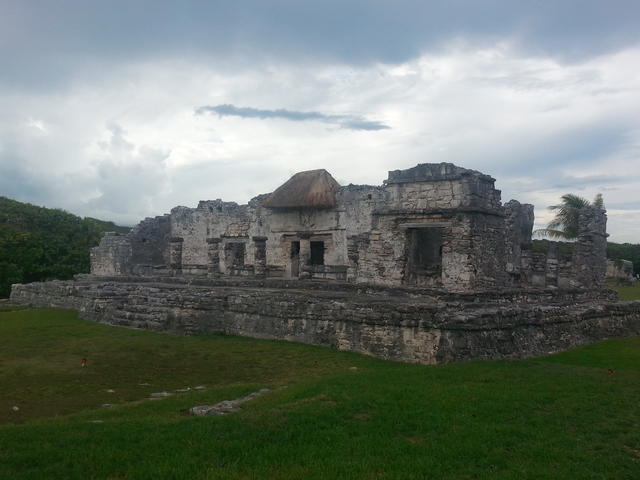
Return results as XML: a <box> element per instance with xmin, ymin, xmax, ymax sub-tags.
<box><xmin>0</xmin><ymin>197</ymin><xmax>131</xmax><ymax>298</ymax></box>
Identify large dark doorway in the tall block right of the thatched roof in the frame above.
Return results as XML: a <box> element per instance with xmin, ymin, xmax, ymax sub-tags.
<box><xmin>405</xmin><ymin>227</ymin><xmax>442</xmax><ymax>285</ymax></box>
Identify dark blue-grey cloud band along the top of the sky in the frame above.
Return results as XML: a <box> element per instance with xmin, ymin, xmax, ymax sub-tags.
<box><xmin>0</xmin><ymin>0</ymin><xmax>640</xmax><ymax>88</ymax></box>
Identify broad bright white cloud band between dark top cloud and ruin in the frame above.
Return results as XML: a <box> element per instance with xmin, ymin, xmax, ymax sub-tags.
<box><xmin>0</xmin><ymin>42</ymin><xmax>640</xmax><ymax>241</ymax></box>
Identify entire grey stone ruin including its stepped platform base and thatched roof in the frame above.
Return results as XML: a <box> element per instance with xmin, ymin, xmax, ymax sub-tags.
<box><xmin>12</xmin><ymin>163</ymin><xmax>640</xmax><ymax>363</ymax></box>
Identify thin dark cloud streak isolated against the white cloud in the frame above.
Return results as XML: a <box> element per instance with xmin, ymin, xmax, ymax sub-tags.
<box><xmin>195</xmin><ymin>104</ymin><xmax>390</xmax><ymax>130</ymax></box>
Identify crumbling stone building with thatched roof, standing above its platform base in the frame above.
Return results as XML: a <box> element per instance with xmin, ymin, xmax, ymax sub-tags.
<box><xmin>92</xmin><ymin>163</ymin><xmax>606</xmax><ymax>292</ymax></box>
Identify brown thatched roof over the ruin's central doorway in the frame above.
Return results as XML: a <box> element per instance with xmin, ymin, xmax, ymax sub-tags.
<box><xmin>263</xmin><ymin>169</ymin><xmax>340</xmax><ymax>208</ymax></box>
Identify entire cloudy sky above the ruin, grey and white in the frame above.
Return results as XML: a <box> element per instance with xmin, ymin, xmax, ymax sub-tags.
<box><xmin>0</xmin><ymin>0</ymin><xmax>640</xmax><ymax>242</ymax></box>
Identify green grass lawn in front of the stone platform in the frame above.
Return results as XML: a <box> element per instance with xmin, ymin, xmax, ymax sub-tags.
<box><xmin>0</xmin><ymin>310</ymin><xmax>640</xmax><ymax>480</ymax></box>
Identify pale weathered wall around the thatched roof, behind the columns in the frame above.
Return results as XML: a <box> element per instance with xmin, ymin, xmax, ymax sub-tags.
<box><xmin>161</xmin><ymin>186</ymin><xmax>390</xmax><ymax>278</ymax></box>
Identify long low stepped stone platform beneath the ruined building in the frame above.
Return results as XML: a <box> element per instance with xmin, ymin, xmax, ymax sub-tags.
<box><xmin>11</xmin><ymin>275</ymin><xmax>640</xmax><ymax>364</ymax></box>
